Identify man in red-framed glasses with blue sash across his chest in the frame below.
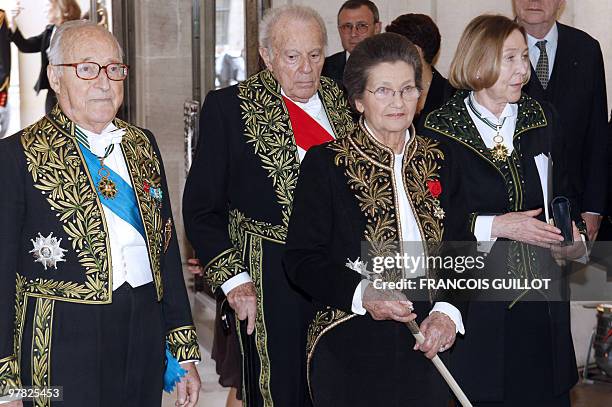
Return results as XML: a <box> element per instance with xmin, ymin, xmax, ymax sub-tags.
<box><xmin>0</xmin><ymin>21</ymin><xmax>200</xmax><ymax>407</ymax></box>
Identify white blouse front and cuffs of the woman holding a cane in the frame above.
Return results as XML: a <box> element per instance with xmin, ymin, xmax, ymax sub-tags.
<box><xmin>351</xmin><ymin>121</ymin><xmax>465</xmax><ymax>334</ymax></box>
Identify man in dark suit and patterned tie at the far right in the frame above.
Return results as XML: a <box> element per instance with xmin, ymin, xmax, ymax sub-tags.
<box><xmin>513</xmin><ymin>0</ymin><xmax>608</xmax><ymax>241</ymax></box>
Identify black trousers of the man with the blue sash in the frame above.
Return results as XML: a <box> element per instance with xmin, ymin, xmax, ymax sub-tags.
<box><xmin>21</xmin><ymin>283</ymin><xmax>165</xmax><ymax>407</ymax></box>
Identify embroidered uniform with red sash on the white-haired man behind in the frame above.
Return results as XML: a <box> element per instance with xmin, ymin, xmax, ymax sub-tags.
<box><xmin>183</xmin><ymin>70</ymin><xmax>353</xmax><ymax>407</ymax></box>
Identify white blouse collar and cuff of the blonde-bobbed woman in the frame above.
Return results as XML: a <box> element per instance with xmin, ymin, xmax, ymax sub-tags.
<box><xmin>463</xmin><ymin>92</ymin><xmax>518</xmax><ymax>253</ymax></box>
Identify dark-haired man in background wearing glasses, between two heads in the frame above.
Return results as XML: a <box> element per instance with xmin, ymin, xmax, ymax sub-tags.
<box><xmin>322</xmin><ymin>0</ymin><xmax>381</xmax><ymax>84</ymax></box>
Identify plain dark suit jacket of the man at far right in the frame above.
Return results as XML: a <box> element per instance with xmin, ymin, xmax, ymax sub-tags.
<box><xmin>523</xmin><ymin>23</ymin><xmax>608</xmax><ymax>213</ymax></box>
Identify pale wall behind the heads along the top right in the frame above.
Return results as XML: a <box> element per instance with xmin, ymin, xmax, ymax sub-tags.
<box><xmin>272</xmin><ymin>0</ymin><xmax>612</xmax><ymax>108</ymax></box>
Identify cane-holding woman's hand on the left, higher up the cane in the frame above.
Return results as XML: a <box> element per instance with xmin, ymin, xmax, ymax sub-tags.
<box><xmin>363</xmin><ymin>284</ymin><xmax>417</xmax><ymax>323</ymax></box>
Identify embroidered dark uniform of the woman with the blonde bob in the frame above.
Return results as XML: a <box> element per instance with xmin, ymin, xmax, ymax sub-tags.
<box><xmin>423</xmin><ymin>91</ymin><xmax>583</xmax><ymax>401</ymax></box>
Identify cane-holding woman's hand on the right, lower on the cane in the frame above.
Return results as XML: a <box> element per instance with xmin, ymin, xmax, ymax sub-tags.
<box><xmin>414</xmin><ymin>311</ymin><xmax>457</xmax><ymax>359</ymax></box>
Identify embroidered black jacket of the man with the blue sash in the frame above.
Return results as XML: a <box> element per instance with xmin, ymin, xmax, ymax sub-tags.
<box><xmin>0</xmin><ymin>106</ymin><xmax>200</xmax><ymax>398</ymax></box>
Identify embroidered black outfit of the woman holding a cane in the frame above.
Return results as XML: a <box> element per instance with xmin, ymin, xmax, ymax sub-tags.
<box><xmin>284</xmin><ymin>124</ymin><xmax>462</xmax><ymax>406</ymax></box>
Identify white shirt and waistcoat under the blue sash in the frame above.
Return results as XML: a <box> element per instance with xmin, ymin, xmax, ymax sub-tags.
<box><xmin>79</xmin><ymin>123</ymin><xmax>153</xmax><ymax>291</ymax></box>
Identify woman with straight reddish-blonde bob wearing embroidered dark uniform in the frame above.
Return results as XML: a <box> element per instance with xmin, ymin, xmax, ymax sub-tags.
<box><xmin>423</xmin><ymin>15</ymin><xmax>584</xmax><ymax>407</ymax></box>
